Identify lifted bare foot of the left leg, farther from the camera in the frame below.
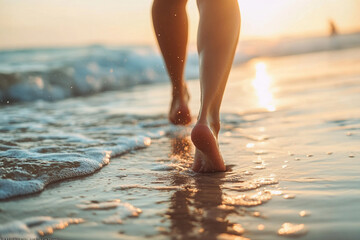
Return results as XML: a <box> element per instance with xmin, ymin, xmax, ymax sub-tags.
<box><xmin>169</xmin><ymin>88</ymin><xmax>191</xmax><ymax>125</ymax></box>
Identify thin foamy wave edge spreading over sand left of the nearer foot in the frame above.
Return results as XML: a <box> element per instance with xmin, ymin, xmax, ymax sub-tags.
<box><xmin>0</xmin><ymin>119</ymin><xmax>177</xmax><ymax>200</ymax></box>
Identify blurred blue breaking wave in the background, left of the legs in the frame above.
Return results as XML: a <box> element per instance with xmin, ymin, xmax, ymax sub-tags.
<box><xmin>0</xmin><ymin>46</ymin><xmax>196</xmax><ymax>103</ymax></box>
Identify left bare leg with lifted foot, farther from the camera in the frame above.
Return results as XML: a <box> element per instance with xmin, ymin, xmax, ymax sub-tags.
<box><xmin>152</xmin><ymin>0</ymin><xmax>191</xmax><ymax>125</ymax></box>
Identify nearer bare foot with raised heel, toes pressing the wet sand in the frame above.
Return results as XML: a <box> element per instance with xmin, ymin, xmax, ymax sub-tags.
<box><xmin>191</xmin><ymin>123</ymin><xmax>226</xmax><ymax>173</ymax></box>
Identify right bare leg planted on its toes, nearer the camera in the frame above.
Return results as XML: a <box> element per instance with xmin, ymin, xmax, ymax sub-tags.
<box><xmin>191</xmin><ymin>0</ymin><xmax>240</xmax><ymax>172</ymax></box>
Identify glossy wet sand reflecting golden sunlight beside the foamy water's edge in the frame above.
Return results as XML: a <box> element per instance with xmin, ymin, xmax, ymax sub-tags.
<box><xmin>0</xmin><ymin>49</ymin><xmax>360</xmax><ymax>240</ymax></box>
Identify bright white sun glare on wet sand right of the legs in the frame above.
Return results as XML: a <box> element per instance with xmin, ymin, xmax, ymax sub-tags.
<box><xmin>252</xmin><ymin>62</ymin><xmax>276</xmax><ymax>112</ymax></box>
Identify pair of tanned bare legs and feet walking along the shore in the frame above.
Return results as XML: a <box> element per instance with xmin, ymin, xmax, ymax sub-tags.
<box><xmin>152</xmin><ymin>0</ymin><xmax>240</xmax><ymax>172</ymax></box>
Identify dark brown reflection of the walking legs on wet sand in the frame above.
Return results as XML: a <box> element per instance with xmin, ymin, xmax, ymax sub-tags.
<box><xmin>166</xmin><ymin>137</ymin><xmax>244</xmax><ymax>239</ymax></box>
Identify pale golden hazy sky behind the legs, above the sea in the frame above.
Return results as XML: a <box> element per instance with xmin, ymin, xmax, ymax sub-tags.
<box><xmin>0</xmin><ymin>0</ymin><xmax>360</xmax><ymax>49</ymax></box>
